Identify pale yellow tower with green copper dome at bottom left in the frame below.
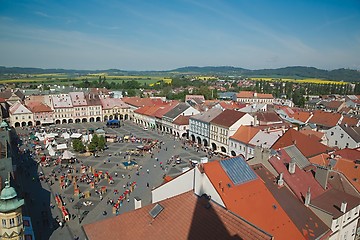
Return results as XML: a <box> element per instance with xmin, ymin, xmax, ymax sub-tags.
<box><xmin>0</xmin><ymin>181</ymin><xmax>24</xmax><ymax>240</ymax></box>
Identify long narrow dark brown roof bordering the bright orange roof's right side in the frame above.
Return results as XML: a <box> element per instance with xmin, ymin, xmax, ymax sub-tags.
<box><xmin>251</xmin><ymin>164</ymin><xmax>331</xmax><ymax>239</ymax></box>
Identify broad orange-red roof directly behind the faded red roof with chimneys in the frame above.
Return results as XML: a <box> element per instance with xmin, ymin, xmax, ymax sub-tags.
<box><xmin>272</xmin><ymin>128</ymin><xmax>331</xmax><ymax>158</ymax></box>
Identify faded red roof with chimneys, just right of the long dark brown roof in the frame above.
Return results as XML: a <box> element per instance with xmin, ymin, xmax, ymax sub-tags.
<box><xmin>269</xmin><ymin>149</ymin><xmax>325</xmax><ymax>202</ymax></box>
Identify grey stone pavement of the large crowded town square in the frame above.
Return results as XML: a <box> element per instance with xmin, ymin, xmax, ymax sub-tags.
<box><xmin>17</xmin><ymin>121</ymin><xmax>211</xmax><ymax>240</ymax></box>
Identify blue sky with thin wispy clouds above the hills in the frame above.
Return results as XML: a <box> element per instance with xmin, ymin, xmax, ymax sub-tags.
<box><xmin>0</xmin><ymin>0</ymin><xmax>360</xmax><ymax>70</ymax></box>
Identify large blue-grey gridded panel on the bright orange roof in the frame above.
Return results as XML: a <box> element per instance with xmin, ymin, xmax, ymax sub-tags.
<box><xmin>220</xmin><ymin>157</ymin><xmax>257</xmax><ymax>185</ymax></box>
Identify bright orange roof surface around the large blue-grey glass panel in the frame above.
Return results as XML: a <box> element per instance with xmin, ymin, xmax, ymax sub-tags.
<box><xmin>204</xmin><ymin>160</ymin><xmax>305</xmax><ymax>240</ymax></box>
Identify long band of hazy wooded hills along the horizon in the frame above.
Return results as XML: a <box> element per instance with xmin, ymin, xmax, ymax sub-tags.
<box><xmin>0</xmin><ymin>66</ymin><xmax>360</xmax><ymax>82</ymax></box>
